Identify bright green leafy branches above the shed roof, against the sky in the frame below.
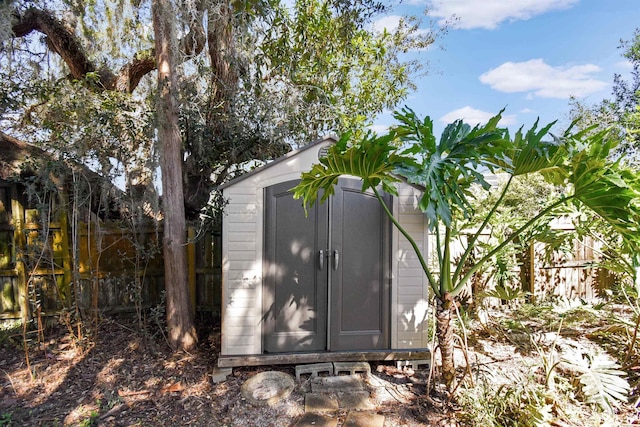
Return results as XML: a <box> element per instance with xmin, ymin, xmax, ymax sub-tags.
<box><xmin>251</xmin><ymin>0</ymin><xmax>438</xmax><ymax>138</ymax></box>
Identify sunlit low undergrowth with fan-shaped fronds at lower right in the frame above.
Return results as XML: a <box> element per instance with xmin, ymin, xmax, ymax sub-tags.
<box><xmin>459</xmin><ymin>298</ymin><xmax>637</xmax><ymax>426</ymax></box>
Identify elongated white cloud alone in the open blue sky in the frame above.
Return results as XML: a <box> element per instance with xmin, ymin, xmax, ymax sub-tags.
<box><xmin>480</xmin><ymin>59</ymin><xmax>608</xmax><ymax>99</ymax></box>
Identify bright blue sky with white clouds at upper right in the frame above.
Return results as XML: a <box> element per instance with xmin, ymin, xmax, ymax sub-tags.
<box><xmin>372</xmin><ymin>0</ymin><xmax>640</xmax><ymax>133</ymax></box>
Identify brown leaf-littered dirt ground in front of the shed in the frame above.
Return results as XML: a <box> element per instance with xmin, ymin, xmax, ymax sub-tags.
<box><xmin>0</xmin><ymin>306</ymin><xmax>637</xmax><ymax>427</ymax></box>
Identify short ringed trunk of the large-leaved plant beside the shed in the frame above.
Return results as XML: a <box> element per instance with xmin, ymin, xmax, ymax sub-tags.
<box><xmin>436</xmin><ymin>294</ymin><xmax>456</xmax><ymax>393</ymax></box>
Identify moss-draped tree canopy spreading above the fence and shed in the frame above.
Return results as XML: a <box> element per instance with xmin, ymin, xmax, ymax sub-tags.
<box><xmin>0</xmin><ymin>0</ymin><xmax>446</xmax><ymax>216</ymax></box>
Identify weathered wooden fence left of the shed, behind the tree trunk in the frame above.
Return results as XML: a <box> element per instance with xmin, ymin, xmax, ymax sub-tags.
<box><xmin>0</xmin><ymin>184</ymin><xmax>221</xmax><ymax>319</ymax></box>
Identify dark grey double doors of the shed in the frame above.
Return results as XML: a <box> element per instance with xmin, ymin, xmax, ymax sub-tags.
<box><xmin>262</xmin><ymin>179</ymin><xmax>390</xmax><ymax>353</ymax></box>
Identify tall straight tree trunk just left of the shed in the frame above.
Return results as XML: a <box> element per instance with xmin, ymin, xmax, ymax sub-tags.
<box><xmin>152</xmin><ymin>0</ymin><xmax>198</xmax><ymax>350</ymax></box>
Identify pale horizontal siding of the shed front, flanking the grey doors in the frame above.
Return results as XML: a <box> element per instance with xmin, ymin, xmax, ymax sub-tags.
<box><xmin>221</xmin><ymin>141</ymin><xmax>428</xmax><ymax>355</ymax></box>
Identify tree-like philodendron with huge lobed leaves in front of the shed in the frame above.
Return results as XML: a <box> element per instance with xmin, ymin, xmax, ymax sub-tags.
<box><xmin>293</xmin><ymin>108</ymin><xmax>640</xmax><ymax>391</ymax></box>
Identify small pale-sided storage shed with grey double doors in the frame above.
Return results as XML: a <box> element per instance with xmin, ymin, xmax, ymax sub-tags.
<box><xmin>218</xmin><ymin>138</ymin><xmax>429</xmax><ymax>367</ymax></box>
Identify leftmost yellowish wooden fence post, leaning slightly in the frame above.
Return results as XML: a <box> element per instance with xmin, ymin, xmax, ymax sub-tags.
<box><xmin>11</xmin><ymin>189</ymin><xmax>30</xmax><ymax>324</ymax></box>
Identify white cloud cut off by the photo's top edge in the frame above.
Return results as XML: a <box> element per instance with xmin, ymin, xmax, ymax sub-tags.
<box><xmin>429</xmin><ymin>0</ymin><xmax>579</xmax><ymax>30</ymax></box>
